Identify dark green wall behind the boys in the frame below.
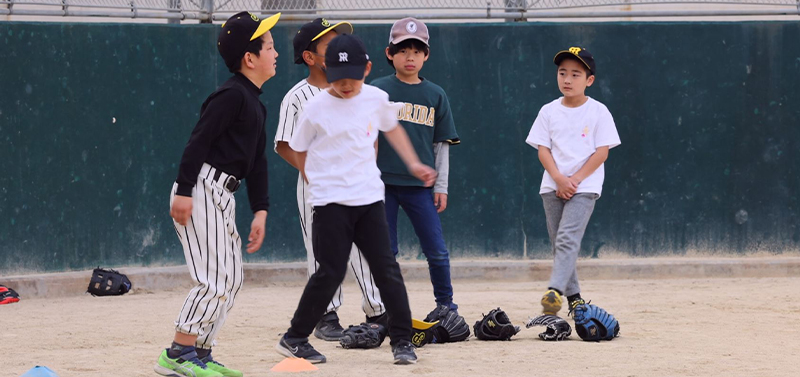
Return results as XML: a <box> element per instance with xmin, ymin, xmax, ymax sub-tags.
<box><xmin>0</xmin><ymin>22</ymin><xmax>800</xmax><ymax>273</ymax></box>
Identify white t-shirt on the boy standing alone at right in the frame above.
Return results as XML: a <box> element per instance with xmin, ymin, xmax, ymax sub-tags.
<box><xmin>525</xmin><ymin>97</ymin><xmax>620</xmax><ymax>195</ymax></box>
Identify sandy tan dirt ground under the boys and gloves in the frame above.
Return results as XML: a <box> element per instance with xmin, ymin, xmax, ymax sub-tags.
<box><xmin>0</xmin><ymin>278</ymin><xmax>800</xmax><ymax>377</ymax></box>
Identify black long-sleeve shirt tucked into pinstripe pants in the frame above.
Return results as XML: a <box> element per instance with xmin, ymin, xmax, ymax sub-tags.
<box><xmin>176</xmin><ymin>73</ymin><xmax>269</xmax><ymax>213</ymax></box>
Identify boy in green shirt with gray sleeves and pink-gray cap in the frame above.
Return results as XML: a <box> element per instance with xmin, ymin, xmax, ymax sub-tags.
<box><xmin>372</xmin><ymin>17</ymin><xmax>459</xmax><ymax>322</ymax></box>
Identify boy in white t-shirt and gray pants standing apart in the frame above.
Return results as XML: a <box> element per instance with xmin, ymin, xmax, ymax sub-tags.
<box><xmin>525</xmin><ymin>47</ymin><xmax>620</xmax><ymax>315</ymax></box>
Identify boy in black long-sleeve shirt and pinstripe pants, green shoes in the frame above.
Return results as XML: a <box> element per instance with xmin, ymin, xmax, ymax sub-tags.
<box><xmin>155</xmin><ymin>12</ymin><xmax>280</xmax><ymax>377</ymax></box>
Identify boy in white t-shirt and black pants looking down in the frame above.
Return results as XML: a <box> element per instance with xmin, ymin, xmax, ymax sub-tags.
<box><xmin>275</xmin><ymin>34</ymin><xmax>436</xmax><ymax>364</ymax></box>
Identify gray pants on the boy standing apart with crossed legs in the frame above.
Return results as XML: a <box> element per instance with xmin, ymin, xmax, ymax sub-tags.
<box><xmin>541</xmin><ymin>192</ymin><xmax>600</xmax><ymax>296</ymax></box>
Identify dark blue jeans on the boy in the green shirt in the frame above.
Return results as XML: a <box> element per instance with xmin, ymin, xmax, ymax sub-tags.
<box><xmin>386</xmin><ymin>185</ymin><xmax>458</xmax><ymax>309</ymax></box>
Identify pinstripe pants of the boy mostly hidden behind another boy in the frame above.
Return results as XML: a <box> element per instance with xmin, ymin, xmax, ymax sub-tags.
<box><xmin>297</xmin><ymin>174</ymin><xmax>386</xmax><ymax>317</ymax></box>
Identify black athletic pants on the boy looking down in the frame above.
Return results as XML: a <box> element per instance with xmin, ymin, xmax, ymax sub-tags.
<box><xmin>286</xmin><ymin>201</ymin><xmax>411</xmax><ymax>345</ymax></box>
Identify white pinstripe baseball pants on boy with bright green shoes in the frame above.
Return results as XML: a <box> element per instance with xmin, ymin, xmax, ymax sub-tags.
<box><xmin>170</xmin><ymin>164</ymin><xmax>244</xmax><ymax>349</ymax></box>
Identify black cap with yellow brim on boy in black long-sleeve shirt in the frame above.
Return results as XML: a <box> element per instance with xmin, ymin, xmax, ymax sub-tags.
<box><xmin>217</xmin><ymin>12</ymin><xmax>281</xmax><ymax>68</ymax></box>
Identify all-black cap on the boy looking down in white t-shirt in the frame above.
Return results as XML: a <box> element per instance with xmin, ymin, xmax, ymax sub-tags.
<box><xmin>325</xmin><ymin>34</ymin><xmax>369</xmax><ymax>82</ymax></box>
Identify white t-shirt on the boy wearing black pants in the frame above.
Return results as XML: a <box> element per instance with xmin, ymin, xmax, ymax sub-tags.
<box><xmin>289</xmin><ymin>85</ymin><xmax>403</xmax><ymax>206</ymax></box>
